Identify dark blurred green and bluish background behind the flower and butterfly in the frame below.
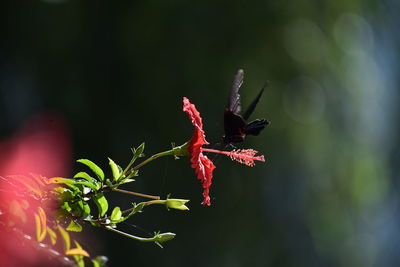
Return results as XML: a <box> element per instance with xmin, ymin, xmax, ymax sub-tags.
<box><xmin>0</xmin><ymin>0</ymin><xmax>400</xmax><ymax>267</ymax></box>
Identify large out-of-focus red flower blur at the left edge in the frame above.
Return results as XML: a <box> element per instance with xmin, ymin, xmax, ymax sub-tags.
<box><xmin>0</xmin><ymin>114</ymin><xmax>71</xmax><ymax>266</ymax></box>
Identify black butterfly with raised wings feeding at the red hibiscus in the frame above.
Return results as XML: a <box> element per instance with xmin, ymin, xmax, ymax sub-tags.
<box><xmin>223</xmin><ymin>69</ymin><xmax>269</xmax><ymax>144</ymax></box>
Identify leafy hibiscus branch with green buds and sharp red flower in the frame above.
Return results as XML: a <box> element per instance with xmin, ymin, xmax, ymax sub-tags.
<box><xmin>0</xmin><ymin>93</ymin><xmax>265</xmax><ymax>267</ymax></box>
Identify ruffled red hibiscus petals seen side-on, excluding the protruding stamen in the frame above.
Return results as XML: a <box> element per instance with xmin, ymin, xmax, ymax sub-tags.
<box><xmin>183</xmin><ymin>97</ymin><xmax>215</xmax><ymax>206</ymax></box>
